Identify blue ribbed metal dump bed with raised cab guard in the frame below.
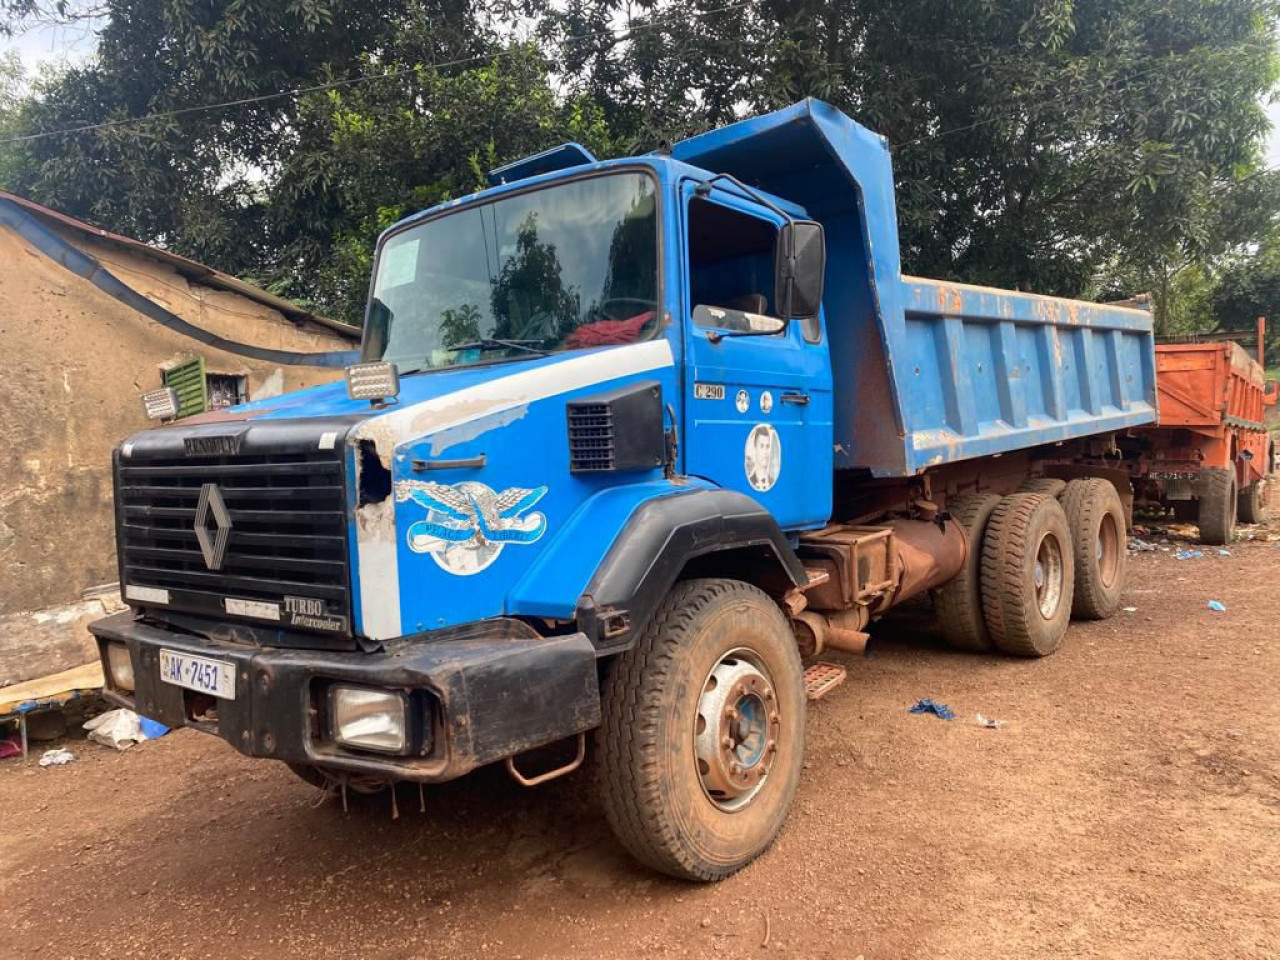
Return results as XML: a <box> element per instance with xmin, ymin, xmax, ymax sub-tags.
<box><xmin>673</xmin><ymin>100</ymin><xmax>1156</xmax><ymax>476</ymax></box>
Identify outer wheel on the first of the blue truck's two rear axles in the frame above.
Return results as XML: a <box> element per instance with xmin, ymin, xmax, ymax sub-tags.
<box><xmin>982</xmin><ymin>493</ymin><xmax>1075</xmax><ymax>657</ymax></box>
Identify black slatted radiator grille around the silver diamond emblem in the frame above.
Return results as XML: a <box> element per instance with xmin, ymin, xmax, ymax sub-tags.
<box><xmin>116</xmin><ymin>453</ymin><xmax>351</xmax><ymax>628</ymax></box>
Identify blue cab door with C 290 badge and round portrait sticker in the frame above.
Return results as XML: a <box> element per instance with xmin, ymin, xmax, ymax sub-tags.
<box><xmin>682</xmin><ymin>184</ymin><xmax>833</xmax><ymax>530</ymax></box>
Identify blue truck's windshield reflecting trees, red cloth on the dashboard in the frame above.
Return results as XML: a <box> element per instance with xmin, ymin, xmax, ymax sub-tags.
<box><xmin>365</xmin><ymin>173</ymin><xmax>658</xmax><ymax>371</ymax></box>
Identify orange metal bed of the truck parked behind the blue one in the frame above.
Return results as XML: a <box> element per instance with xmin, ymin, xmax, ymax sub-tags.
<box><xmin>1156</xmin><ymin>340</ymin><xmax>1266</xmax><ymax>428</ymax></box>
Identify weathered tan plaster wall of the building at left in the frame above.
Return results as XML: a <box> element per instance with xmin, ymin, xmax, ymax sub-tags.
<box><xmin>0</xmin><ymin>227</ymin><xmax>352</xmax><ymax>616</ymax></box>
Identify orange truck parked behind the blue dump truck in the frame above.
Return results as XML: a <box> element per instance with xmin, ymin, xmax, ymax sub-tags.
<box><xmin>1119</xmin><ymin>340</ymin><xmax>1276</xmax><ymax>544</ymax></box>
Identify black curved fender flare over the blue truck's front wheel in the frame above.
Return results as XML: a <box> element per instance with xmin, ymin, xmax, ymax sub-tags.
<box><xmin>575</xmin><ymin>488</ymin><xmax>809</xmax><ymax>653</ymax></box>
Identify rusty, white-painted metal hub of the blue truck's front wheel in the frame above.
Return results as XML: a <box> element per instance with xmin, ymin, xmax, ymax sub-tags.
<box><xmin>694</xmin><ymin>650</ymin><xmax>781</xmax><ymax>812</ymax></box>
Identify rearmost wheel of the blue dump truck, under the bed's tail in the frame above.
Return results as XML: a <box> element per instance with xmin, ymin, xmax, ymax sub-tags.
<box><xmin>1059</xmin><ymin>477</ymin><xmax>1129</xmax><ymax>620</ymax></box>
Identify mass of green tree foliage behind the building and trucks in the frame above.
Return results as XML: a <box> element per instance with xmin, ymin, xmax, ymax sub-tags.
<box><xmin>0</xmin><ymin>0</ymin><xmax>1280</xmax><ymax>329</ymax></box>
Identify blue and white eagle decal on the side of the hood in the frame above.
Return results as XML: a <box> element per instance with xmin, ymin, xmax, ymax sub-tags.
<box><xmin>396</xmin><ymin>480</ymin><xmax>547</xmax><ymax>576</ymax></box>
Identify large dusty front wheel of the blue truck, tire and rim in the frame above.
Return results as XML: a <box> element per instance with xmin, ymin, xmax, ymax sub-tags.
<box><xmin>596</xmin><ymin>580</ymin><xmax>805</xmax><ymax>881</ymax></box>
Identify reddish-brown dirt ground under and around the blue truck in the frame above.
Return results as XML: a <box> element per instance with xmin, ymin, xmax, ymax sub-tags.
<box><xmin>0</xmin><ymin>526</ymin><xmax>1280</xmax><ymax>960</ymax></box>
